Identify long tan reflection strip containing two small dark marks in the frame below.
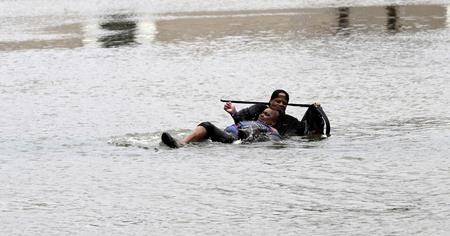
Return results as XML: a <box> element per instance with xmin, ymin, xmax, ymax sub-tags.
<box><xmin>155</xmin><ymin>5</ymin><xmax>447</xmax><ymax>42</ymax></box>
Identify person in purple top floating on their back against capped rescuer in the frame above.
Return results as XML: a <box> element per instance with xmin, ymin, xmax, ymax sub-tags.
<box><xmin>161</xmin><ymin>107</ymin><xmax>281</xmax><ymax>148</ymax></box>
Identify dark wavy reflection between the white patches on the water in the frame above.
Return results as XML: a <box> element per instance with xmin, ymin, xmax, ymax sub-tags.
<box><xmin>98</xmin><ymin>14</ymin><xmax>137</xmax><ymax>48</ymax></box>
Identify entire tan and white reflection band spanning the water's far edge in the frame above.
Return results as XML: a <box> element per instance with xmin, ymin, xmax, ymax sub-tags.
<box><xmin>0</xmin><ymin>5</ymin><xmax>447</xmax><ymax>51</ymax></box>
